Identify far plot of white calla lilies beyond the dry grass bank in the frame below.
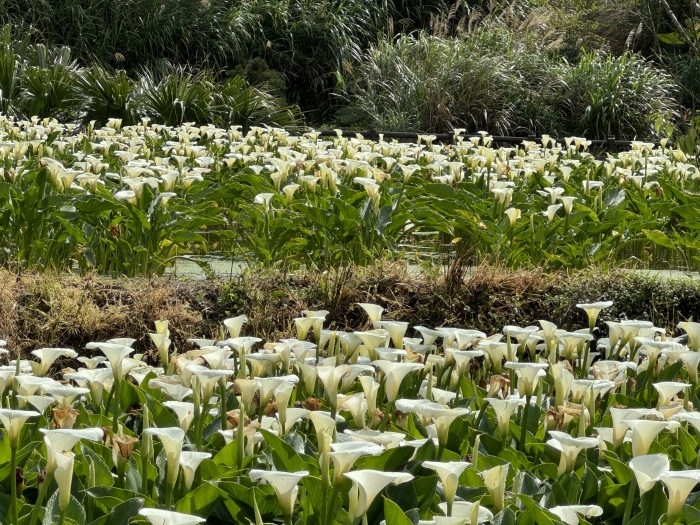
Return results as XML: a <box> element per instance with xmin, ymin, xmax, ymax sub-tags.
<box><xmin>0</xmin><ymin>117</ymin><xmax>700</xmax><ymax>276</ymax></box>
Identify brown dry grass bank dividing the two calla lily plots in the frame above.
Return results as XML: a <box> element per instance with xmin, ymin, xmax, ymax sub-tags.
<box><xmin>0</xmin><ymin>262</ymin><xmax>700</xmax><ymax>366</ymax></box>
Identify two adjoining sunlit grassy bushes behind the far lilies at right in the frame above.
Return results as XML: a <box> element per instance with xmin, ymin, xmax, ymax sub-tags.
<box><xmin>350</xmin><ymin>27</ymin><xmax>677</xmax><ymax>139</ymax></box>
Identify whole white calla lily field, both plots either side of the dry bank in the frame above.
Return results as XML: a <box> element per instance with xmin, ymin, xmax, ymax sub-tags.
<box><xmin>6</xmin><ymin>116</ymin><xmax>700</xmax><ymax>525</ymax></box>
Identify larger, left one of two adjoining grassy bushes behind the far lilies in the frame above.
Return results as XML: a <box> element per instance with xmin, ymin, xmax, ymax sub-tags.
<box><xmin>348</xmin><ymin>28</ymin><xmax>558</xmax><ymax>134</ymax></box>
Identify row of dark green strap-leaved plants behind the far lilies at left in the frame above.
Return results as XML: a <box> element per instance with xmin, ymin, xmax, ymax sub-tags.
<box><xmin>0</xmin><ymin>25</ymin><xmax>300</xmax><ymax>130</ymax></box>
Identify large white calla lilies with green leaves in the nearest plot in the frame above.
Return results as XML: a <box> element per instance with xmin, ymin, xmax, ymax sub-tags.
<box><xmin>0</xmin><ymin>301</ymin><xmax>700</xmax><ymax>525</ymax></box>
